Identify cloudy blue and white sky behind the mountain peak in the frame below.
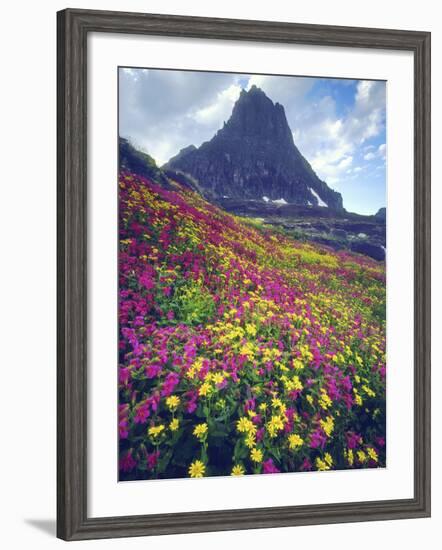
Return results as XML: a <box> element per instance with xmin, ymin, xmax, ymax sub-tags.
<box><xmin>119</xmin><ymin>68</ymin><xmax>386</xmax><ymax>214</ymax></box>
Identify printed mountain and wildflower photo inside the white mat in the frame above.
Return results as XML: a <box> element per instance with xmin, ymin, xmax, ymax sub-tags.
<box><xmin>118</xmin><ymin>67</ymin><xmax>387</xmax><ymax>481</ymax></box>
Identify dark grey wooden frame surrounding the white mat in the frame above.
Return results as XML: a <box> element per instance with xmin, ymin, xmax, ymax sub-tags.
<box><xmin>57</xmin><ymin>9</ymin><xmax>430</xmax><ymax>540</ymax></box>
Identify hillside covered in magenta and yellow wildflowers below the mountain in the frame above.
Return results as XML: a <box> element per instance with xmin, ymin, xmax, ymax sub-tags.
<box><xmin>119</xmin><ymin>172</ymin><xmax>385</xmax><ymax>480</ymax></box>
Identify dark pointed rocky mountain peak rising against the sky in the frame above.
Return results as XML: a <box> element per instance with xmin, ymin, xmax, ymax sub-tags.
<box><xmin>164</xmin><ymin>86</ymin><xmax>343</xmax><ymax>211</ymax></box>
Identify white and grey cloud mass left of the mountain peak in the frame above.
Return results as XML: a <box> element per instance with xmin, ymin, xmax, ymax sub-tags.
<box><xmin>119</xmin><ymin>69</ymin><xmax>240</xmax><ymax>164</ymax></box>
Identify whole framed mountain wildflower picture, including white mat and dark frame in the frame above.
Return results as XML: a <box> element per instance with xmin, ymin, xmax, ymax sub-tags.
<box><xmin>57</xmin><ymin>9</ymin><xmax>430</xmax><ymax>540</ymax></box>
